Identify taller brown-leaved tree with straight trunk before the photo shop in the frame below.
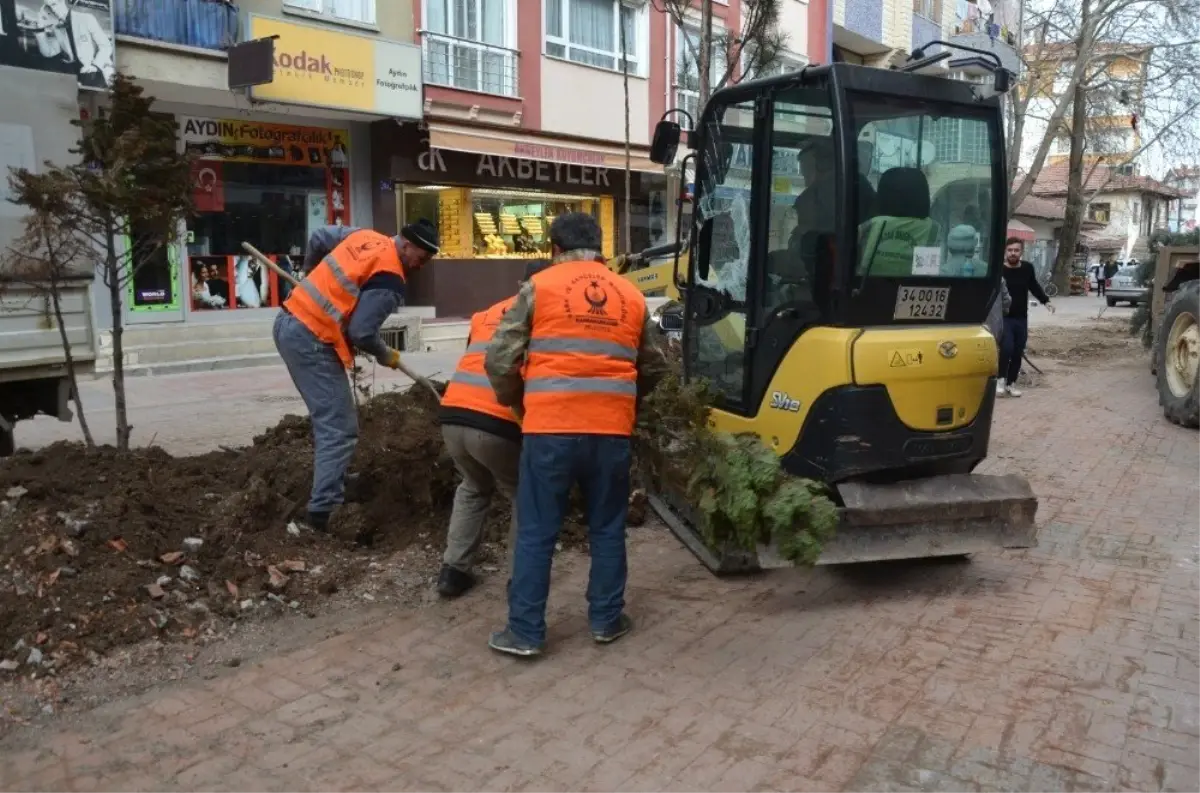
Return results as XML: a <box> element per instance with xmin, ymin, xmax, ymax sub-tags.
<box><xmin>8</xmin><ymin>74</ymin><xmax>192</xmax><ymax>451</ymax></box>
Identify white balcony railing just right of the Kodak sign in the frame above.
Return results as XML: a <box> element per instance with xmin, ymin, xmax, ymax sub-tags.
<box><xmin>420</xmin><ymin>30</ymin><xmax>520</xmax><ymax>96</ymax></box>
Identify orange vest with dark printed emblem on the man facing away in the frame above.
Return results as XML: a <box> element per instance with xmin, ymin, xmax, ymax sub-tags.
<box><xmin>522</xmin><ymin>262</ymin><xmax>646</xmax><ymax>435</ymax></box>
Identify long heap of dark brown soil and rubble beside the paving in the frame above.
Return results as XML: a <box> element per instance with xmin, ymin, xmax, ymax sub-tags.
<box><xmin>0</xmin><ymin>389</ymin><xmax>509</xmax><ymax>672</ymax></box>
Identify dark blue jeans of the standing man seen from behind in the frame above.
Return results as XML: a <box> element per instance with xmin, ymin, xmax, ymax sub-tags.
<box><xmin>509</xmin><ymin>434</ymin><xmax>632</xmax><ymax>644</ymax></box>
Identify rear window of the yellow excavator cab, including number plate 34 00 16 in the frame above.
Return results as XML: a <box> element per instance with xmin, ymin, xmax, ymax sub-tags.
<box><xmin>844</xmin><ymin>94</ymin><xmax>1000</xmax><ymax>325</ymax></box>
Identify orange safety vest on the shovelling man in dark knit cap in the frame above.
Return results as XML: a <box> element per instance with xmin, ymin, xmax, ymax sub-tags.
<box><xmin>283</xmin><ymin>229</ymin><xmax>404</xmax><ymax>368</ymax></box>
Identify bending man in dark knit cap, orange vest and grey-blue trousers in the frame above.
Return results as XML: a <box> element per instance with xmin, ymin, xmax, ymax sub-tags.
<box><xmin>275</xmin><ymin>220</ymin><xmax>438</xmax><ymax>531</ymax></box>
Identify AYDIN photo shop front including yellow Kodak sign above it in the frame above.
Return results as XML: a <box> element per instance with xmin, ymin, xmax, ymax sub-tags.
<box><xmin>114</xmin><ymin>14</ymin><xmax>422</xmax><ymax>324</ymax></box>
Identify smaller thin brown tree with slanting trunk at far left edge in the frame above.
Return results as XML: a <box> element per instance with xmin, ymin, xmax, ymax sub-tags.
<box><xmin>0</xmin><ymin>169</ymin><xmax>96</xmax><ymax>449</ymax></box>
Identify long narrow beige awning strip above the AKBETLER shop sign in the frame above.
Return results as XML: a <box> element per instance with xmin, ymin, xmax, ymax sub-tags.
<box><xmin>428</xmin><ymin>122</ymin><xmax>664</xmax><ymax>174</ymax></box>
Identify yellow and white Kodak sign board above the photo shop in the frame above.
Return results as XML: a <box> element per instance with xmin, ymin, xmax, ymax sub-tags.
<box><xmin>247</xmin><ymin>14</ymin><xmax>424</xmax><ymax>119</ymax></box>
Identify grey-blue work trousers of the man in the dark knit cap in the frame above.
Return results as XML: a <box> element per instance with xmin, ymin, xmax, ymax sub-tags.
<box><xmin>274</xmin><ymin>311</ymin><xmax>359</xmax><ymax>513</ymax></box>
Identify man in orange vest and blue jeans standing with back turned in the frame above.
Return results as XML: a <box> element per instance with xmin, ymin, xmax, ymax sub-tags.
<box><xmin>484</xmin><ymin>212</ymin><xmax>666</xmax><ymax>656</ymax></box>
